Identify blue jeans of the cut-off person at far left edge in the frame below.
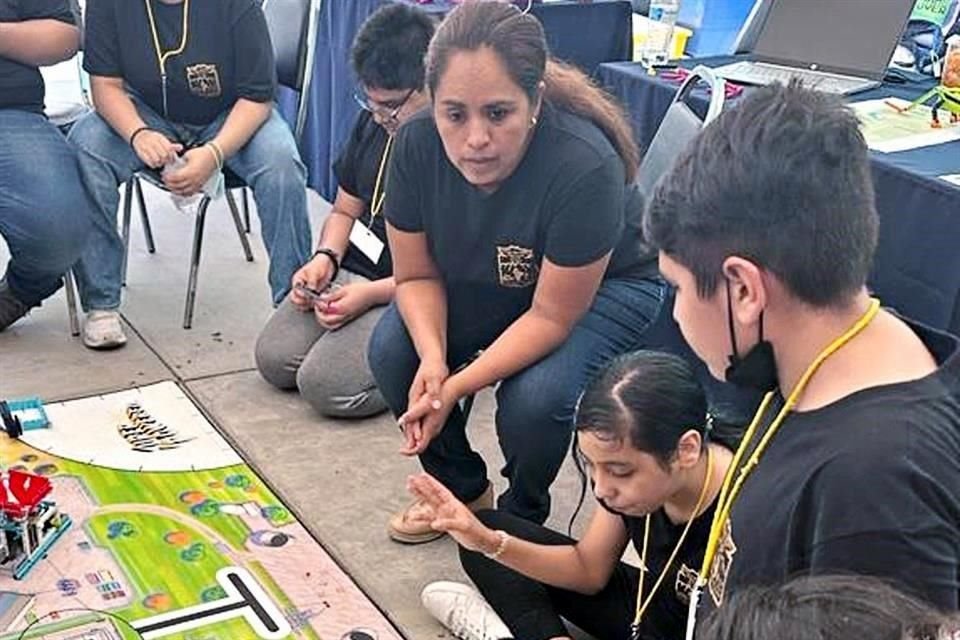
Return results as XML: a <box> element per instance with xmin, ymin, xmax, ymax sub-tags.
<box><xmin>0</xmin><ymin>109</ymin><xmax>93</xmax><ymax>307</ymax></box>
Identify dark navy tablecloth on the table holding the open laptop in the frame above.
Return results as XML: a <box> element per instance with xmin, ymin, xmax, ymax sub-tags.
<box><xmin>597</xmin><ymin>58</ymin><xmax>960</xmax><ymax>333</ymax></box>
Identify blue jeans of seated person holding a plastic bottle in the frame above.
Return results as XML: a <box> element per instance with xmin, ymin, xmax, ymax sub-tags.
<box><xmin>69</xmin><ymin>96</ymin><xmax>310</xmax><ymax>311</ymax></box>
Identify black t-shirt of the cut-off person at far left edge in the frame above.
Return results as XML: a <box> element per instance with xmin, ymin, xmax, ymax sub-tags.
<box><xmin>0</xmin><ymin>0</ymin><xmax>75</xmax><ymax>113</ymax></box>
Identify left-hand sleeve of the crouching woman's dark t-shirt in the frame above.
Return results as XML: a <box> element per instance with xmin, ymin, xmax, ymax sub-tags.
<box><xmin>384</xmin><ymin>119</ymin><xmax>429</xmax><ymax>233</ymax></box>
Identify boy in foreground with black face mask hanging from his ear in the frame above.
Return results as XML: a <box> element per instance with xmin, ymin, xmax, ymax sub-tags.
<box><xmin>645</xmin><ymin>85</ymin><xmax>960</xmax><ymax>624</ymax></box>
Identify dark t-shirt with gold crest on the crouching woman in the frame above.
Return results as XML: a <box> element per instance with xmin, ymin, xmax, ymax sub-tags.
<box><xmin>385</xmin><ymin>105</ymin><xmax>656</xmax><ymax>328</ymax></box>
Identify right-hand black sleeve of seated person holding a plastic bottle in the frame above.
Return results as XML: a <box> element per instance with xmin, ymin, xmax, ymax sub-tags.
<box><xmin>232</xmin><ymin>0</ymin><xmax>277</xmax><ymax>102</ymax></box>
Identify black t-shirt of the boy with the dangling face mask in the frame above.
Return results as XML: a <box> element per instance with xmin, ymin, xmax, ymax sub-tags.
<box><xmin>698</xmin><ymin>323</ymin><xmax>960</xmax><ymax>619</ymax></box>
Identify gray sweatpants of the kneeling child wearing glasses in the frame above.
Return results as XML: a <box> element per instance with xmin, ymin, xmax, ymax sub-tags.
<box><xmin>255</xmin><ymin>271</ymin><xmax>387</xmax><ymax>418</ymax></box>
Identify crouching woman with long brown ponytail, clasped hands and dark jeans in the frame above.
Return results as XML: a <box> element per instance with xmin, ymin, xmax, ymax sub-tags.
<box><xmin>369</xmin><ymin>2</ymin><xmax>664</xmax><ymax>543</ymax></box>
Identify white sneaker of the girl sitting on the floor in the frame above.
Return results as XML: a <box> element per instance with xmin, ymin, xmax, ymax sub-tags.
<box><xmin>420</xmin><ymin>581</ymin><xmax>513</xmax><ymax>640</ymax></box>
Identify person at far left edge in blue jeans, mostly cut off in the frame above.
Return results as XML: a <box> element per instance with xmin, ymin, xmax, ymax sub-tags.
<box><xmin>0</xmin><ymin>0</ymin><xmax>92</xmax><ymax>331</ymax></box>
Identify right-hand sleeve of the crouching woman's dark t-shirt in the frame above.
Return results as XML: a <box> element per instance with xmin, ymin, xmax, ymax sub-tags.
<box><xmin>544</xmin><ymin>155</ymin><xmax>626</xmax><ymax>267</ymax></box>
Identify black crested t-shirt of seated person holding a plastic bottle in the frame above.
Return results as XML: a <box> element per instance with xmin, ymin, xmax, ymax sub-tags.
<box><xmin>83</xmin><ymin>0</ymin><xmax>277</xmax><ymax>125</ymax></box>
